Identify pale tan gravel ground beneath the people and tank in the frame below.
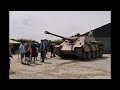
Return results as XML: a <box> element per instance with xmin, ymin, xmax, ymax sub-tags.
<box><xmin>9</xmin><ymin>53</ymin><xmax>111</xmax><ymax>79</ymax></box>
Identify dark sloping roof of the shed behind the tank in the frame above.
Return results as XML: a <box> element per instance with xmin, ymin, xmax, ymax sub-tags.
<box><xmin>83</xmin><ymin>23</ymin><xmax>111</xmax><ymax>37</ymax></box>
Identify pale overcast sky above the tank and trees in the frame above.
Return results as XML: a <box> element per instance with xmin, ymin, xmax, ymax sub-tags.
<box><xmin>9</xmin><ymin>11</ymin><xmax>111</xmax><ymax>41</ymax></box>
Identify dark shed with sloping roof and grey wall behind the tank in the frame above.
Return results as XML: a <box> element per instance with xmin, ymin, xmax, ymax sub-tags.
<box><xmin>83</xmin><ymin>23</ymin><xmax>111</xmax><ymax>53</ymax></box>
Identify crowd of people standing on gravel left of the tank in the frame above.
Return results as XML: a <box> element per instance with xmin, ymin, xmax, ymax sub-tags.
<box><xmin>9</xmin><ymin>40</ymin><xmax>55</xmax><ymax>69</ymax></box>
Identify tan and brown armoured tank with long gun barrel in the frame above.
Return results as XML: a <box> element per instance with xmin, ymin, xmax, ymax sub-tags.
<box><xmin>45</xmin><ymin>31</ymin><xmax>104</xmax><ymax>59</ymax></box>
